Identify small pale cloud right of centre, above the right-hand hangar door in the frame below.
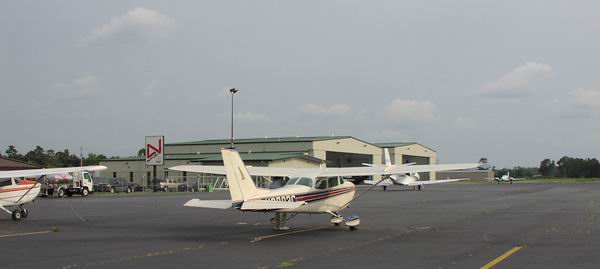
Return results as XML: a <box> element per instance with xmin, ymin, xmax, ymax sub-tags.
<box><xmin>384</xmin><ymin>98</ymin><xmax>435</xmax><ymax>124</ymax></box>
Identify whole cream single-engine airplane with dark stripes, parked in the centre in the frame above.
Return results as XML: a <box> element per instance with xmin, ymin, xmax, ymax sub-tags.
<box><xmin>169</xmin><ymin>149</ymin><xmax>479</xmax><ymax>230</ymax></box>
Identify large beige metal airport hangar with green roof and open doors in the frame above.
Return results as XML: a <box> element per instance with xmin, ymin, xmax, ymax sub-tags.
<box><xmin>100</xmin><ymin>136</ymin><xmax>437</xmax><ymax>186</ymax></box>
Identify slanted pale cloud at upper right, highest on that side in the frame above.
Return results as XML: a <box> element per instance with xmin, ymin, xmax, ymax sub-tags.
<box><xmin>478</xmin><ymin>62</ymin><xmax>552</xmax><ymax>99</ymax></box>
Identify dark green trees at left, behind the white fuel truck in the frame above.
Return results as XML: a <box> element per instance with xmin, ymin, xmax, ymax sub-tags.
<box><xmin>0</xmin><ymin>145</ymin><xmax>118</xmax><ymax>168</ymax></box>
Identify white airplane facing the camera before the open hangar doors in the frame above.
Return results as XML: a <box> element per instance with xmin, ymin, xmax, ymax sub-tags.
<box><xmin>363</xmin><ymin>148</ymin><xmax>468</xmax><ymax>191</ymax></box>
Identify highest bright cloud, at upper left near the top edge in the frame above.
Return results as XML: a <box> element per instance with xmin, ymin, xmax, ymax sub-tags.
<box><xmin>81</xmin><ymin>7</ymin><xmax>177</xmax><ymax>46</ymax></box>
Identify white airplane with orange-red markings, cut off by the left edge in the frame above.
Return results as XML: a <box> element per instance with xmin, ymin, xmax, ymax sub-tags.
<box><xmin>0</xmin><ymin>165</ymin><xmax>106</xmax><ymax>221</ymax></box>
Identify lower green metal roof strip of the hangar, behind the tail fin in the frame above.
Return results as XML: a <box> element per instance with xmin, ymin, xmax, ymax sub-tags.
<box><xmin>103</xmin><ymin>151</ymin><xmax>323</xmax><ymax>162</ymax></box>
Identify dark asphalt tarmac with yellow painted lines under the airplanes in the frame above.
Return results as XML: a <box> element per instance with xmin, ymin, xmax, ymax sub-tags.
<box><xmin>0</xmin><ymin>183</ymin><xmax>600</xmax><ymax>268</ymax></box>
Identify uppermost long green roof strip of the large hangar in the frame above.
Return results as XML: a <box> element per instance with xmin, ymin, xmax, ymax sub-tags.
<box><xmin>166</xmin><ymin>136</ymin><xmax>352</xmax><ymax>146</ymax></box>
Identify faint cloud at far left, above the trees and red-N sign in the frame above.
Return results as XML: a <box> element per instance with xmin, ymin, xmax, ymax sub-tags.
<box><xmin>52</xmin><ymin>76</ymin><xmax>104</xmax><ymax>101</ymax></box>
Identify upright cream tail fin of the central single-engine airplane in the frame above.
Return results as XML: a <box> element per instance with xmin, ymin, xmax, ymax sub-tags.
<box><xmin>221</xmin><ymin>149</ymin><xmax>259</xmax><ymax>202</ymax></box>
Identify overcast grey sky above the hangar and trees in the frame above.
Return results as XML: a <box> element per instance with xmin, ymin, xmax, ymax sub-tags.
<box><xmin>0</xmin><ymin>0</ymin><xmax>600</xmax><ymax>167</ymax></box>
